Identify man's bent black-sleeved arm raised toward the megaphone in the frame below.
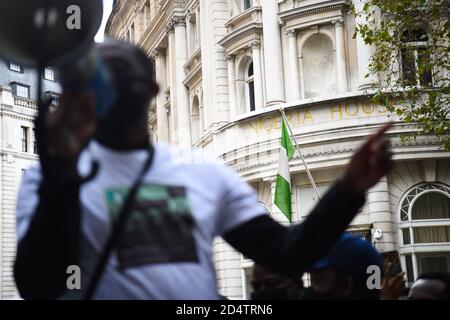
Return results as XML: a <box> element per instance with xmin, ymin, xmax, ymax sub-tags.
<box><xmin>14</xmin><ymin>94</ymin><xmax>94</xmax><ymax>299</ymax></box>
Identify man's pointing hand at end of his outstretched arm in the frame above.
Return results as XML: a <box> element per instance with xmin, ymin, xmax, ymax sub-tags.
<box><xmin>342</xmin><ymin>122</ymin><xmax>392</xmax><ymax>193</ymax></box>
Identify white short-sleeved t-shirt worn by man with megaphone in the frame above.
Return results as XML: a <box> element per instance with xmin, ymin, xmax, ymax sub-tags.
<box><xmin>17</xmin><ymin>141</ymin><xmax>265</xmax><ymax>299</ymax></box>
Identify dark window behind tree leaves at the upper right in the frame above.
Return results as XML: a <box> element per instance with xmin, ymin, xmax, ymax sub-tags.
<box><xmin>400</xmin><ymin>29</ymin><xmax>433</xmax><ymax>86</ymax></box>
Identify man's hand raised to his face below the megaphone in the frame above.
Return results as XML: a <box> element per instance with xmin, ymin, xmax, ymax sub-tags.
<box><xmin>46</xmin><ymin>92</ymin><xmax>96</xmax><ymax>171</ymax></box>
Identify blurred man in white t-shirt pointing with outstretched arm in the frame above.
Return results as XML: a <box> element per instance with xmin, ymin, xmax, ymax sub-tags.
<box><xmin>15</xmin><ymin>40</ymin><xmax>391</xmax><ymax>299</ymax></box>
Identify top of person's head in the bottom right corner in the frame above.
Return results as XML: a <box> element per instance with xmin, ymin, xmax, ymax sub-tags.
<box><xmin>408</xmin><ymin>272</ymin><xmax>450</xmax><ymax>300</ymax></box>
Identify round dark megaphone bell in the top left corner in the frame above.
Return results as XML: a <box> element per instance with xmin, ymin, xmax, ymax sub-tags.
<box><xmin>0</xmin><ymin>0</ymin><xmax>103</xmax><ymax>67</ymax></box>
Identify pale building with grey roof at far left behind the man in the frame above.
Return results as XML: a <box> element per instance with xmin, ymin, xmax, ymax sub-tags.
<box><xmin>0</xmin><ymin>60</ymin><xmax>60</xmax><ymax>299</ymax></box>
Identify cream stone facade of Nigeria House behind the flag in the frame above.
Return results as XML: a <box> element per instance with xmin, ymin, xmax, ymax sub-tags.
<box><xmin>106</xmin><ymin>0</ymin><xmax>450</xmax><ymax>298</ymax></box>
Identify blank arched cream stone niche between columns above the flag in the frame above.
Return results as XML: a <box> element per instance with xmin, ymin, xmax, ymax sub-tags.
<box><xmin>302</xmin><ymin>33</ymin><xmax>336</xmax><ymax>98</ymax></box>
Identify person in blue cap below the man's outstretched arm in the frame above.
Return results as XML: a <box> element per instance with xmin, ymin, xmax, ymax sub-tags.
<box><xmin>304</xmin><ymin>233</ymin><xmax>383</xmax><ymax>300</ymax></box>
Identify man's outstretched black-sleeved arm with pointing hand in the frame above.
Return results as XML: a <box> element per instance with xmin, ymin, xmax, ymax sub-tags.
<box><xmin>224</xmin><ymin>124</ymin><xmax>392</xmax><ymax>277</ymax></box>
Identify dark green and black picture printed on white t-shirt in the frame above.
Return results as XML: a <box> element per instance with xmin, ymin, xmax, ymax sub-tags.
<box><xmin>106</xmin><ymin>185</ymin><xmax>198</xmax><ymax>269</ymax></box>
